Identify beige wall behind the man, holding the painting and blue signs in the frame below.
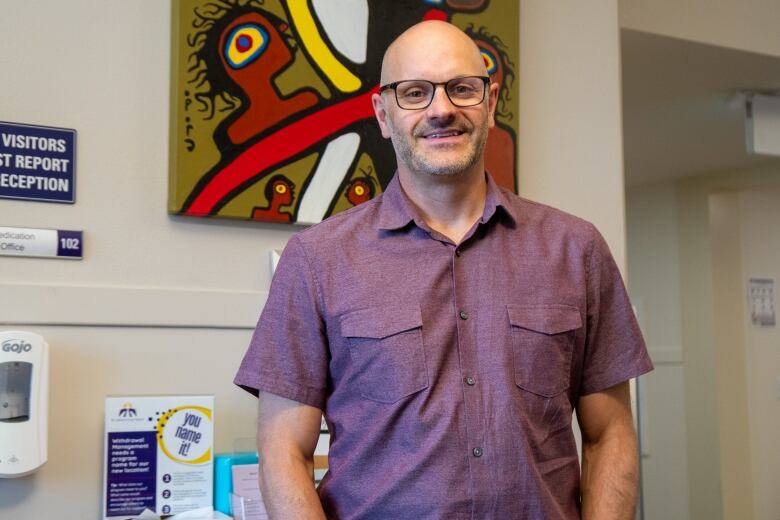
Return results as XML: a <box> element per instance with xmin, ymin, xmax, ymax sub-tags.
<box><xmin>0</xmin><ymin>0</ymin><xmax>624</xmax><ymax>520</ymax></box>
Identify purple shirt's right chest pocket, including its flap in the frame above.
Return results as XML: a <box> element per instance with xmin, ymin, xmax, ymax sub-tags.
<box><xmin>507</xmin><ymin>304</ymin><xmax>582</xmax><ymax>397</ymax></box>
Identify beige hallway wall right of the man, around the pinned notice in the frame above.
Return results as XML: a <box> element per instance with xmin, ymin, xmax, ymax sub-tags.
<box><xmin>627</xmin><ymin>168</ymin><xmax>780</xmax><ymax>520</ymax></box>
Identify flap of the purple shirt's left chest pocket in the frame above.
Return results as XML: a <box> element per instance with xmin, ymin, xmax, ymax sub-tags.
<box><xmin>341</xmin><ymin>306</ymin><xmax>422</xmax><ymax>339</ymax></box>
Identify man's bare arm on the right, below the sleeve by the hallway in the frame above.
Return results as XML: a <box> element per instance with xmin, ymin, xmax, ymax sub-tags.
<box><xmin>577</xmin><ymin>382</ymin><xmax>639</xmax><ymax>520</ymax></box>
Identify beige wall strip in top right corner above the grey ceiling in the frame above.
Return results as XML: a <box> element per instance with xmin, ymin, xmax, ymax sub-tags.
<box><xmin>619</xmin><ymin>0</ymin><xmax>780</xmax><ymax>56</ymax></box>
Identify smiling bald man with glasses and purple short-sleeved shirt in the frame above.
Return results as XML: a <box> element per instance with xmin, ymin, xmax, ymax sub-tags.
<box><xmin>236</xmin><ymin>21</ymin><xmax>652</xmax><ymax>520</ymax></box>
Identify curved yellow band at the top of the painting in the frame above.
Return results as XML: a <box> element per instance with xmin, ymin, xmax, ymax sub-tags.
<box><xmin>287</xmin><ymin>0</ymin><xmax>361</xmax><ymax>92</ymax></box>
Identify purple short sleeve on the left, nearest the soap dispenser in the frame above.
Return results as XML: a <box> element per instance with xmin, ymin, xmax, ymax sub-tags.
<box><xmin>233</xmin><ymin>236</ymin><xmax>328</xmax><ymax>409</ymax></box>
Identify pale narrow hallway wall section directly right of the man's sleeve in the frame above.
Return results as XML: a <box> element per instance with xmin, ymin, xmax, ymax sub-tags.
<box><xmin>626</xmin><ymin>181</ymin><xmax>689</xmax><ymax>520</ymax></box>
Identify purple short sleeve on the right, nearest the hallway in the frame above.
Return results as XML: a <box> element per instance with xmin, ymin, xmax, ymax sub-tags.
<box><xmin>580</xmin><ymin>228</ymin><xmax>653</xmax><ymax>395</ymax></box>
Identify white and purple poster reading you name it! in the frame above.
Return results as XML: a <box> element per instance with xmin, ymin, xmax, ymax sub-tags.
<box><xmin>103</xmin><ymin>396</ymin><xmax>214</xmax><ymax>519</ymax></box>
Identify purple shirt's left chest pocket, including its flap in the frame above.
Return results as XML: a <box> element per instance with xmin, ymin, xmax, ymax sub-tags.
<box><xmin>341</xmin><ymin>306</ymin><xmax>428</xmax><ymax>403</ymax></box>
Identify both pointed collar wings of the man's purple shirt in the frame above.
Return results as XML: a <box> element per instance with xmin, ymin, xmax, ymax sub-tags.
<box><xmin>378</xmin><ymin>172</ymin><xmax>517</xmax><ymax>230</ymax></box>
